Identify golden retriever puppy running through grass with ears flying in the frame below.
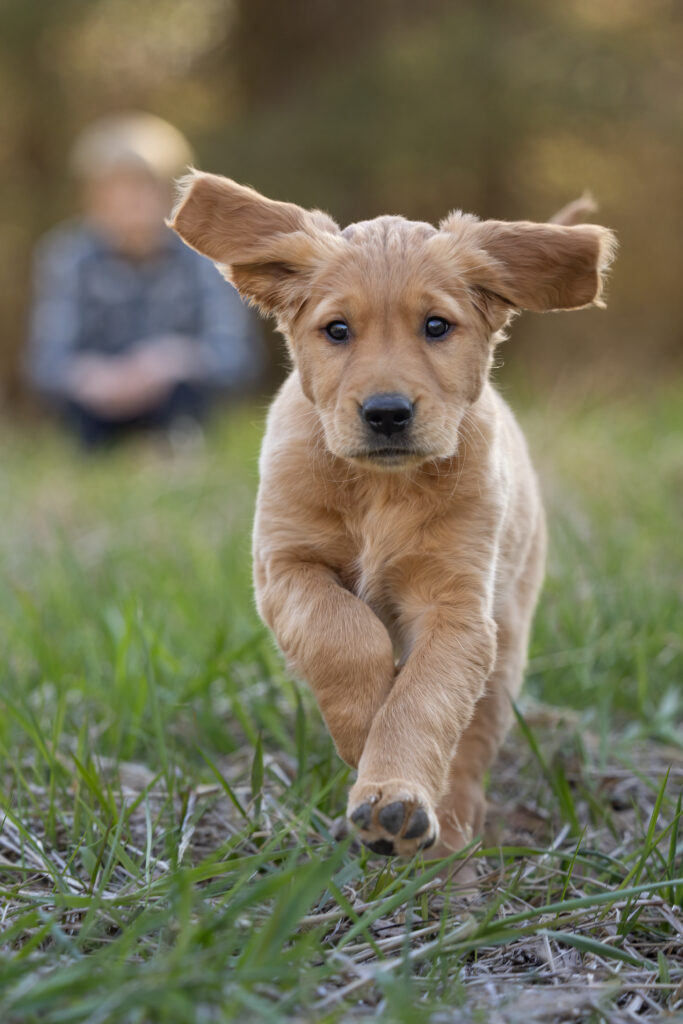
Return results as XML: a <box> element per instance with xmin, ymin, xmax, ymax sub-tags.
<box><xmin>171</xmin><ymin>173</ymin><xmax>614</xmax><ymax>857</ymax></box>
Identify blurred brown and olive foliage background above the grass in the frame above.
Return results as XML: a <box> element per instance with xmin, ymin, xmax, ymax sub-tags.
<box><xmin>0</xmin><ymin>0</ymin><xmax>683</xmax><ymax>401</ymax></box>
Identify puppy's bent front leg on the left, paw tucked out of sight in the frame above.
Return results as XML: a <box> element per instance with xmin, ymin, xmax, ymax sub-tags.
<box><xmin>256</xmin><ymin>560</ymin><xmax>395</xmax><ymax>767</ymax></box>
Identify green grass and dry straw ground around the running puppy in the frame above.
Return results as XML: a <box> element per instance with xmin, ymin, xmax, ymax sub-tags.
<box><xmin>0</xmin><ymin>384</ymin><xmax>683</xmax><ymax>1024</ymax></box>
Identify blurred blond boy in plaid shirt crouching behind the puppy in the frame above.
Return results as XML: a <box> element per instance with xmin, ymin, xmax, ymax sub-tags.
<box><xmin>27</xmin><ymin>114</ymin><xmax>262</xmax><ymax>446</ymax></box>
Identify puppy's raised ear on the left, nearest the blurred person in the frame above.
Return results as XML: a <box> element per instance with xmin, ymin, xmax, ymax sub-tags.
<box><xmin>168</xmin><ymin>171</ymin><xmax>339</xmax><ymax>314</ymax></box>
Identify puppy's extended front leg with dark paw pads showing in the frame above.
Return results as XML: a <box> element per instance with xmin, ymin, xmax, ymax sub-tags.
<box><xmin>348</xmin><ymin>590</ymin><xmax>496</xmax><ymax>856</ymax></box>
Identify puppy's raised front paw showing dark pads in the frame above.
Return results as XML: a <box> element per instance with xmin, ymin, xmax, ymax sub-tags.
<box><xmin>347</xmin><ymin>779</ymin><xmax>439</xmax><ymax>858</ymax></box>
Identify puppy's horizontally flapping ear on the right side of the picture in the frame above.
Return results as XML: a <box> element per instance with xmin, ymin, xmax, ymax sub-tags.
<box><xmin>439</xmin><ymin>213</ymin><xmax>616</xmax><ymax>312</ymax></box>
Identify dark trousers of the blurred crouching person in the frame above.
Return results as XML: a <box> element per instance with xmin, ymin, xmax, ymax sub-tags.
<box><xmin>65</xmin><ymin>383</ymin><xmax>209</xmax><ymax>449</ymax></box>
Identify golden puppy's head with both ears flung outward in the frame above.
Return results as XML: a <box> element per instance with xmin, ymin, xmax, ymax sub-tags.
<box><xmin>170</xmin><ymin>173</ymin><xmax>615</xmax><ymax>469</ymax></box>
